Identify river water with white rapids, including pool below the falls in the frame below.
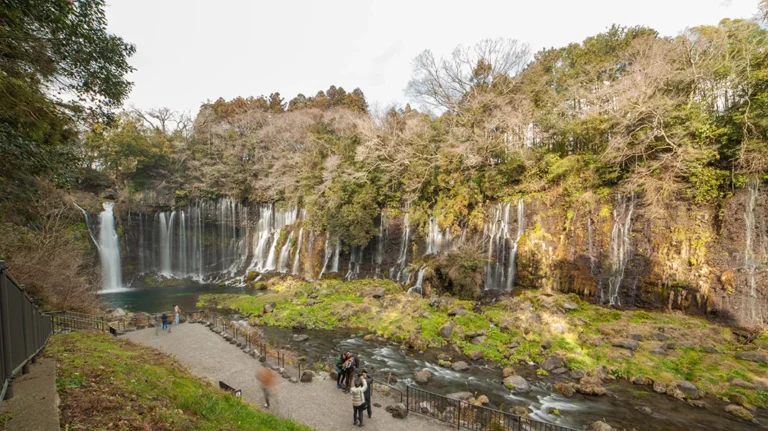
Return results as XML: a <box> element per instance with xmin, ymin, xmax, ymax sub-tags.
<box><xmin>102</xmin><ymin>284</ymin><xmax>768</xmax><ymax>431</ymax></box>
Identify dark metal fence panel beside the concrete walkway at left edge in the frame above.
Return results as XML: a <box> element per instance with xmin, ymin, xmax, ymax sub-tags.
<box><xmin>0</xmin><ymin>260</ymin><xmax>53</xmax><ymax>405</ymax></box>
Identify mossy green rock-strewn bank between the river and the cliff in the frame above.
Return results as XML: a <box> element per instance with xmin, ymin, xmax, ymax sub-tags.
<box><xmin>198</xmin><ymin>280</ymin><xmax>768</xmax><ymax>407</ymax></box>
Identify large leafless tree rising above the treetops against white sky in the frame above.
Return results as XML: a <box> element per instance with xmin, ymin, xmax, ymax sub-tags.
<box><xmin>406</xmin><ymin>38</ymin><xmax>530</xmax><ymax>111</ymax></box>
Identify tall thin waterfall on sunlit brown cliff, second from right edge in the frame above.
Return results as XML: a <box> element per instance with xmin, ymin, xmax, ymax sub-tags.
<box><xmin>608</xmin><ymin>193</ymin><xmax>635</xmax><ymax>305</ymax></box>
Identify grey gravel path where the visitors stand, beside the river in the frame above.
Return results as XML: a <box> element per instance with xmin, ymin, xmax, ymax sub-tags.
<box><xmin>123</xmin><ymin>323</ymin><xmax>449</xmax><ymax>431</ymax></box>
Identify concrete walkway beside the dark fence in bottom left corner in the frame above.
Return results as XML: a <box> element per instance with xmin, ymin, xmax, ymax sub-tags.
<box><xmin>0</xmin><ymin>358</ymin><xmax>59</xmax><ymax>431</ymax></box>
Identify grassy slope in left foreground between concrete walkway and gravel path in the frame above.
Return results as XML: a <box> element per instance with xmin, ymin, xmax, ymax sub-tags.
<box><xmin>46</xmin><ymin>333</ymin><xmax>310</xmax><ymax>431</ymax></box>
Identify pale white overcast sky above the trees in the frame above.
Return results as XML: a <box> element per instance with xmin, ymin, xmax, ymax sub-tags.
<box><xmin>107</xmin><ymin>0</ymin><xmax>758</xmax><ymax>115</ymax></box>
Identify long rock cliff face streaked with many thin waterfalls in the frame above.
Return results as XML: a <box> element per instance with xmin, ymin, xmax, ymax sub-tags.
<box><xmin>116</xmin><ymin>182</ymin><xmax>768</xmax><ymax>326</ymax></box>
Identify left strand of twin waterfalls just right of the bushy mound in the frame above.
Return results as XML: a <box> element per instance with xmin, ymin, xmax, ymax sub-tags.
<box><xmin>485</xmin><ymin>203</ymin><xmax>511</xmax><ymax>289</ymax></box>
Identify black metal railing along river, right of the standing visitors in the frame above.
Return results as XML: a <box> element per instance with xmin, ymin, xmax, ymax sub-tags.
<box><xmin>405</xmin><ymin>386</ymin><xmax>576</xmax><ymax>431</ymax></box>
